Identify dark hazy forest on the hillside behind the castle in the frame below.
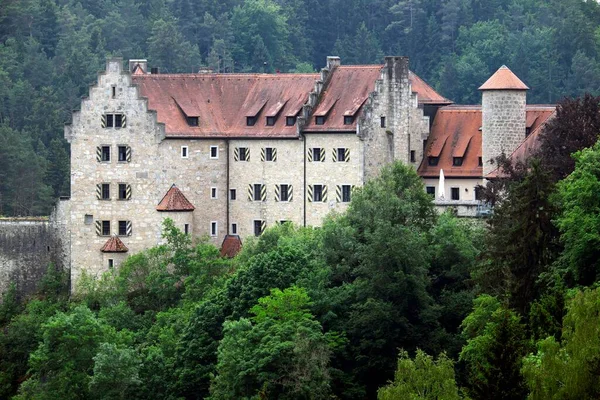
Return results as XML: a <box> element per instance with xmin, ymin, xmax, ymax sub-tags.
<box><xmin>0</xmin><ymin>0</ymin><xmax>600</xmax><ymax>216</ymax></box>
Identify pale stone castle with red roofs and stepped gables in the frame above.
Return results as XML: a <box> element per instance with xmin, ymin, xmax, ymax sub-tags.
<box><xmin>57</xmin><ymin>57</ymin><xmax>555</xmax><ymax>282</ymax></box>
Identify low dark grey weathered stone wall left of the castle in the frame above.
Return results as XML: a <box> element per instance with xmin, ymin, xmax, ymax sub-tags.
<box><xmin>0</xmin><ymin>218</ymin><xmax>65</xmax><ymax>299</ymax></box>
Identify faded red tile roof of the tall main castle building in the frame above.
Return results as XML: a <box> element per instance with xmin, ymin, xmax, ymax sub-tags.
<box><xmin>132</xmin><ymin>65</ymin><xmax>451</xmax><ymax>138</ymax></box>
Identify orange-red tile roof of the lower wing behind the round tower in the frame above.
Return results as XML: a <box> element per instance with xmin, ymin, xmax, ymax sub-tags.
<box><xmin>418</xmin><ymin>105</ymin><xmax>555</xmax><ymax>178</ymax></box>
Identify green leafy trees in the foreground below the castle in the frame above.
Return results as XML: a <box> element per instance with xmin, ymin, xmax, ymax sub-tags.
<box><xmin>5</xmin><ymin>94</ymin><xmax>600</xmax><ymax>400</ymax></box>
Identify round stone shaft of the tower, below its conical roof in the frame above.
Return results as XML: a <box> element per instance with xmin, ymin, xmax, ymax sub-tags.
<box><xmin>481</xmin><ymin>90</ymin><xmax>527</xmax><ymax>176</ymax></box>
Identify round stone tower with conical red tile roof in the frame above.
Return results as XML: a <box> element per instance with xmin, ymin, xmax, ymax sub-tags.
<box><xmin>479</xmin><ymin>65</ymin><xmax>529</xmax><ymax>177</ymax></box>
